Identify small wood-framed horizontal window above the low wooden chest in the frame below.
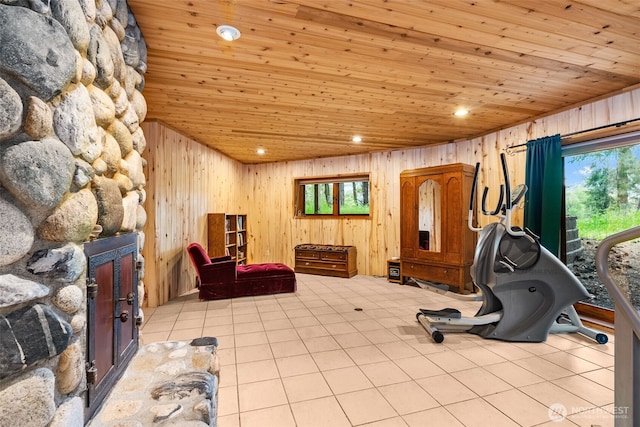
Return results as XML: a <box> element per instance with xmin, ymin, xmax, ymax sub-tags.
<box><xmin>295</xmin><ymin>175</ymin><xmax>370</xmax><ymax>217</ymax></box>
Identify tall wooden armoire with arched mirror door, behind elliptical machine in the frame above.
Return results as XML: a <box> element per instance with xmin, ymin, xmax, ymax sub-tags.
<box><xmin>400</xmin><ymin>163</ymin><xmax>476</xmax><ymax>293</ymax></box>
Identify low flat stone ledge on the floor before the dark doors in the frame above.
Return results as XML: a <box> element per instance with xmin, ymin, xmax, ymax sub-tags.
<box><xmin>87</xmin><ymin>337</ymin><xmax>220</xmax><ymax>427</ymax></box>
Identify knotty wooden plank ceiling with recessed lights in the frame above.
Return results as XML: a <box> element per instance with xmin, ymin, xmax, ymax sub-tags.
<box><xmin>128</xmin><ymin>0</ymin><xmax>640</xmax><ymax>163</ymax></box>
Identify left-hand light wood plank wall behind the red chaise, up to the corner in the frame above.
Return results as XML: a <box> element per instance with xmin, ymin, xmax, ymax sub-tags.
<box><xmin>142</xmin><ymin>122</ymin><xmax>247</xmax><ymax>307</ymax></box>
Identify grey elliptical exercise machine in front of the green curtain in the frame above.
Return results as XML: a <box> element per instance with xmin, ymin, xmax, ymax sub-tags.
<box><xmin>416</xmin><ymin>153</ymin><xmax>608</xmax><ymax>344</ymax></box>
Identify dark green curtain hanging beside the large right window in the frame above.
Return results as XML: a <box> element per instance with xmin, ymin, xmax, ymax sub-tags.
<box><xmin>524</xmin><ymin>134</ymin><xmax>563</xmax><ymax>256</ymax></box>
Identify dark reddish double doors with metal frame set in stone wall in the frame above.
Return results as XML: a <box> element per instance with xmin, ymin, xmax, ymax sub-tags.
<box><xmin>84</xmin><ymin>233</ymin><xmax>139</xmax><ymax>420</ymax></box>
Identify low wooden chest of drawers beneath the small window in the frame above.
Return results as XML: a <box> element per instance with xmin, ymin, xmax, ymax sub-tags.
<box><xmin>295</xmin><ymin>244</ymin><xmax>358</xmax><ymax>278</ymax></box>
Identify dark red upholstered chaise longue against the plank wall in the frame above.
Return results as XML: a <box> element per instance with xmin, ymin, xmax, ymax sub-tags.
<box><xmin>187</xmin><ymin>243</ymin><xmax>296</xmax><ymax>300</ymax></box>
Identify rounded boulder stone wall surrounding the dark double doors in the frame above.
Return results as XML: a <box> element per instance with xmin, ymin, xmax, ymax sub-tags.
<box><xmin>0</xmin><ymin>0</ymin><xmax>146</xmax><ymax>426</ymax></box>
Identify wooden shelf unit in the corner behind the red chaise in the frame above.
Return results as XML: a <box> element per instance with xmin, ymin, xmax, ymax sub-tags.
<box><xmin>207</xmin><ymin>213</ymin><xmax>247</xmax><ymax>265</ymax></box>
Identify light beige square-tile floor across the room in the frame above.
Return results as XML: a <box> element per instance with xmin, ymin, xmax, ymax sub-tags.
<box><xmin>142</xmin><ymin>274</ymin><xmax>614</xmax><ymax>427</ymax></box>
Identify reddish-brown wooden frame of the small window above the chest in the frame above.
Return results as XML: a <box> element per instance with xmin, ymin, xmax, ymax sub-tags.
<box><xmin>293</xmin><ymin>173</ymin><xmax>371</xmax><ymax>219</ymax></box>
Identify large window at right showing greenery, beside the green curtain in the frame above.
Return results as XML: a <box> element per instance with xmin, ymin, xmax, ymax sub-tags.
<box><xmin>562</xmin><ymin>132</ymin><xmax>640</xmax><ymax>323</ymax></box>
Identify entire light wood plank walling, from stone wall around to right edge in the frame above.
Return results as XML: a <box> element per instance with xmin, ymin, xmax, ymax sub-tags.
<box><xmin>143</xmin><ymin>89</ymin><xmax>640</xmax><ymax>307</ymax></box>
